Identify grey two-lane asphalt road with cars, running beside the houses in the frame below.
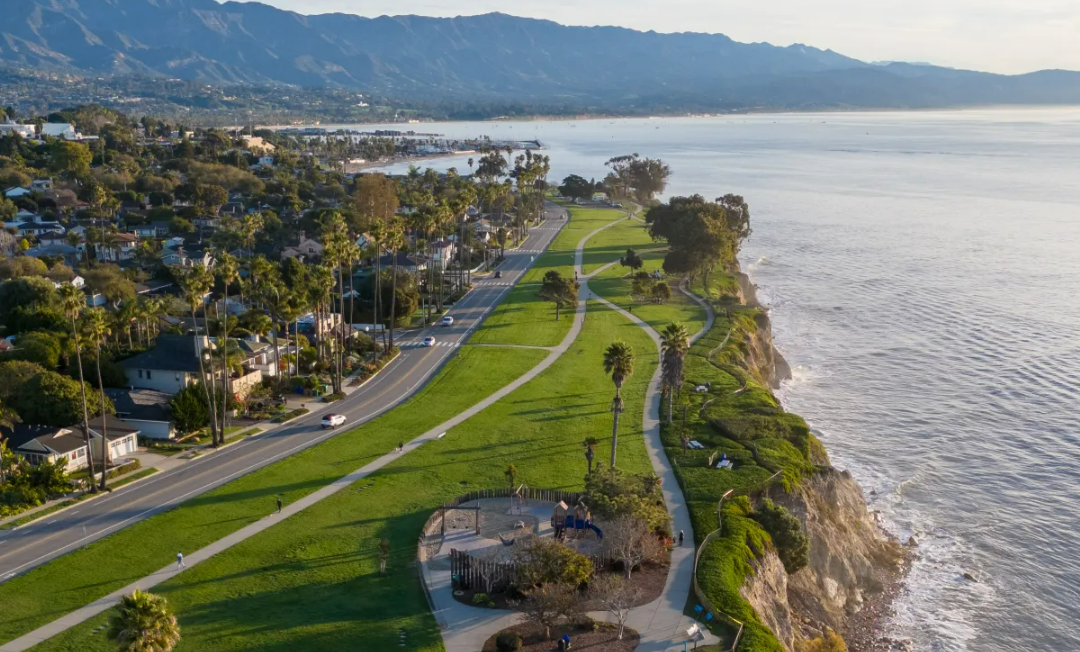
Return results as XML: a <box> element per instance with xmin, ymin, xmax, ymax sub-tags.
<box><xmin>0</xmin><ymin>205</ymin><xmax>566</xmax><ymax>583</ymax></box>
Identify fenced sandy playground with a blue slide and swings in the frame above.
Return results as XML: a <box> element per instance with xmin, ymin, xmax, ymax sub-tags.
<box><xmin>438</xmin><ymin>497</ymin><xmax>604</xmax><ymax>561</ymax></box>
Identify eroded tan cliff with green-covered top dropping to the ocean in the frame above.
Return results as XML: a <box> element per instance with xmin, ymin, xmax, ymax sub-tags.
<box><xmin>682</xmin><ymin>273</ymin><xmax>903</xmax><ymax>652</ymax></box>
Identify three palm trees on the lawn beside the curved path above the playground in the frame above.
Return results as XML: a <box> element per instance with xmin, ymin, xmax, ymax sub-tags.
<box><xmin>600</xmin><ymin>322</ymin><xmax>690</xmax><ymax>473</ymax></box>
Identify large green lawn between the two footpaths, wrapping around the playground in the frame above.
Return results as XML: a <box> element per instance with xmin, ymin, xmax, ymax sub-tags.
<box><xmin>35</xmin><ymin>308</ymin><xmax>658</xmax><ymax>652</ymax></box>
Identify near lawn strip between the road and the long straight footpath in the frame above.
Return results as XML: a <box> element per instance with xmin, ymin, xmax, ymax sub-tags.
<box><xmin>0</xmin><ymin>348</ymin><xmax>544</xmax><ymax>641</ymax></box>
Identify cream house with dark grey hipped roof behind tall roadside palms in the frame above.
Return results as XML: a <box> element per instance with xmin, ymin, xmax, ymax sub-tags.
<box><xmin>120</xmin><ymin>334</ymin><xmax>218</xmax><ymax>395</ymax></box>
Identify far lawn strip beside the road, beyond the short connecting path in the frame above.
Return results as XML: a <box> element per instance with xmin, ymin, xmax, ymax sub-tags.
<box><xmin>470</xmin><ymin>206</ymin><xmax>621</xmax><ymax>347</ymax></box>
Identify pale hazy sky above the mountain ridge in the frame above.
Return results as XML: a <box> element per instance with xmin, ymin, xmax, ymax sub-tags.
<box><xmin>238</xmin><ymin>0</ymin><xmax>1080</xmax><ymax>72</ymax></box>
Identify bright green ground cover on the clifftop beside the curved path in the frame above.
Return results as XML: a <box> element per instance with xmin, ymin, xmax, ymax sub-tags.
<box><xmin>662</xmin><ymin>274</ymin><xmax>824</xmax><ymax>652</ymax></box>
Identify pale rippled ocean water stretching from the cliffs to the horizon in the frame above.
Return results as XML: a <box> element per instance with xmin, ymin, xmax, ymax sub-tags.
<box><xmin>362</xmin><ymin>109</ymin><xmax>1080</xmax><ymax>652</ymax></box>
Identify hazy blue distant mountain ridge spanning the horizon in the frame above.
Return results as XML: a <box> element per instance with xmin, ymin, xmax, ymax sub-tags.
<box><xmin>0</xmin><ymin>0</ymin><xmax>1080</xmax><ymax>110</ymax></box>
